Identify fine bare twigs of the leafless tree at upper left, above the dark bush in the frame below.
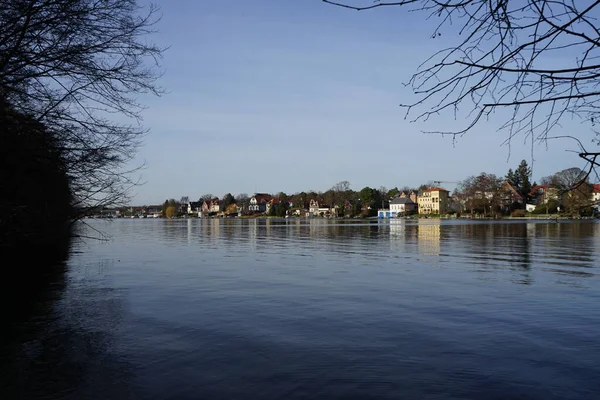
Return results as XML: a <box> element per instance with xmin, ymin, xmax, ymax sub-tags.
<box><xmin>0</xmin><ymin>0</ymin><xmax>163</xmax><ymax>216</ymax></box>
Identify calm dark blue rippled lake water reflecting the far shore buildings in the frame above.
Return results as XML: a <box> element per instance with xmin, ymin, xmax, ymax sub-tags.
<box><xmin>0</xmin><ymin>219</ymin><xmax>600</xmax><ymax>399</ymax></box>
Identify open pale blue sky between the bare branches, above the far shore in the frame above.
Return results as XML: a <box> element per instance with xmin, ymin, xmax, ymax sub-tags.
<box><xmin>127</xmin><ymin>0</ymin><xmax>596</xmax><ymax>204</ymax></box>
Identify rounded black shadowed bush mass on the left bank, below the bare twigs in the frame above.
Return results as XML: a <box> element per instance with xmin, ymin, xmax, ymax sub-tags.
<box><xmin>0</xmin><ymin>101</ymin><xmax>73</xmax><ymax>248</ymax></box>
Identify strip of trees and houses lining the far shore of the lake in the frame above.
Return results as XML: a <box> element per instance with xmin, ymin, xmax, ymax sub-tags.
<box><xmin>117</xmin><ymin>160</ymin><xmax>600</xmax><ymax>218</ymax></box>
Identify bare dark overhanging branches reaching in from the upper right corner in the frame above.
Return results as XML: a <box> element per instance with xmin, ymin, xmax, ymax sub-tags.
<box><xmin>323</xmin><ymin>0</ymin><xmax>600</xmax><ymax>177</ymax></box>
